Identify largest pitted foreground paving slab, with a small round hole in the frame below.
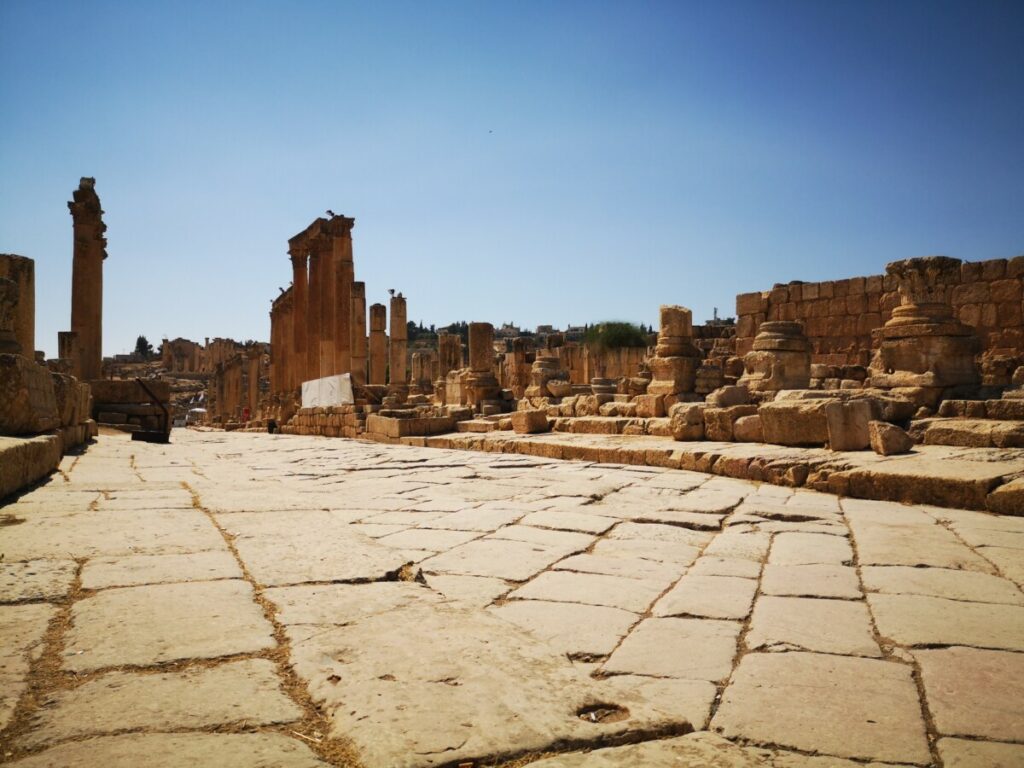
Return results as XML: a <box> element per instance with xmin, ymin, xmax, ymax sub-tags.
<box><xmin>278</xmin><ymin>584</ymin><xmax>690</xmax><ymax>768</ymax></box>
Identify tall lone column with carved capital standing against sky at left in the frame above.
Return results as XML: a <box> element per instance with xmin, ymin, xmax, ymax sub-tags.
<box><xmin>67</xmin><ymin>178</ymin><xmax>106</xmax><ymax>381</ymax></box>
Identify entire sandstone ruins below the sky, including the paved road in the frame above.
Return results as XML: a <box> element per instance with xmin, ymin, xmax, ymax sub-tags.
<box><xmin>0</xmin><ymin>186</ymin><xmax>1024</xmax><ymax>768</ymax></box>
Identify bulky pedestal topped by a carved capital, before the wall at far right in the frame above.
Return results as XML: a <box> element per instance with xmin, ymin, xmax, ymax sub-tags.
<box><xmin>869</xmin><ymin>256</ymin><xmax>981</xmax><ymax>408</ymax></box>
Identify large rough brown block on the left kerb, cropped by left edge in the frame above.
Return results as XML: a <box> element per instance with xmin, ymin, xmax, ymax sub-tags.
<box><xmin>0</xmin><ymin>354</ymin><xmax>60</xmax><ymax>435</ymax></box>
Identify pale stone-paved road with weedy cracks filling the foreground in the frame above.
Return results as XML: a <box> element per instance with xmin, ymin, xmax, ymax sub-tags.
<box><xmin>0</xmin><ymin>431</ymin><xmax>1024</xmax><ymax>768</ymax></box>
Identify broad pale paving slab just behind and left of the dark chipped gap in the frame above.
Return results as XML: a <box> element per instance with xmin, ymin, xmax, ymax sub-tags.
<box><xmin>217</xmin><ymin>511</ymin><xmax>409</xmax><ymax>587</ymax></box>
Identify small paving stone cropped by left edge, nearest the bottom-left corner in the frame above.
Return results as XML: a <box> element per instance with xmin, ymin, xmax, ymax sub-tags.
<box><xmin>0</xmin><ymin>603</ymin><xmax>56</xmax><ymax>730</ymax></box>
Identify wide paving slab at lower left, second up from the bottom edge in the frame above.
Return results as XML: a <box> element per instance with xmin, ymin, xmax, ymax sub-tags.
<box><xmin>22</xmin><ymin>658</ymin><xmax>302</xmax><ymax>748</ymax></box>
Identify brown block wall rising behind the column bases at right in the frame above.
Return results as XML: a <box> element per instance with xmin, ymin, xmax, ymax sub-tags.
<box><xmin>736</xmin><ymin>256</ymin><xmax>1024</xmax><ymax>366</ymax></box>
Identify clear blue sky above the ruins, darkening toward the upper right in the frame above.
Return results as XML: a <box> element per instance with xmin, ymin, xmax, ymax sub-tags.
<box><xmin>0</xmin><ymin>0</ymin><xmax>1024</xmax><ymax>355</ymax></box>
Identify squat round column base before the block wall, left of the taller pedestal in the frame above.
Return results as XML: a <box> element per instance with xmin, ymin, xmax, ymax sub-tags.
<box><xmin>736</xmin><ymin>321</ymin><xmax>811</xmax><ymax>392</ymax></box>
